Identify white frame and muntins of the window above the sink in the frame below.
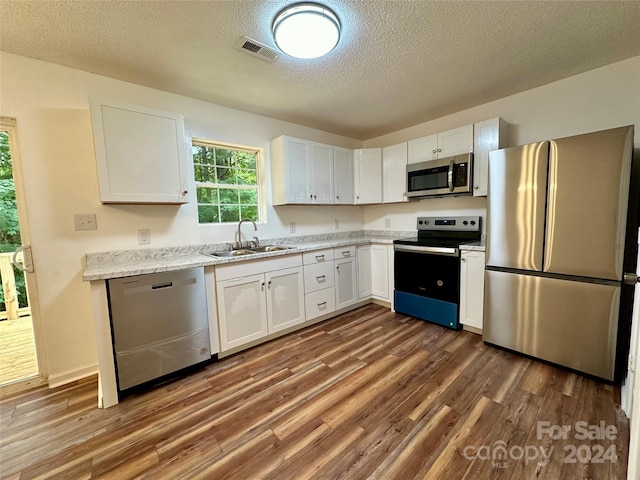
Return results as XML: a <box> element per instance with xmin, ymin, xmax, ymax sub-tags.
<box><xmin>191</xmin><ymin>137</ymin><xmax>266</xmax><ymax>226</ymax></box>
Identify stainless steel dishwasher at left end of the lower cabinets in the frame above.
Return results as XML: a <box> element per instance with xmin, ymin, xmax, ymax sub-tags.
<box><xmin>107</xmin><ymin>268</ymin><xmax>211</xmax><ymax>392</ymax></box>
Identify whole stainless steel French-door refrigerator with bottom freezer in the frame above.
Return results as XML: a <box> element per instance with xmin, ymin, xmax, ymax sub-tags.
<box><xmin>483</xmin><ymin>126</ymin><xmax>637</xmax><ymax>380</ymax></box>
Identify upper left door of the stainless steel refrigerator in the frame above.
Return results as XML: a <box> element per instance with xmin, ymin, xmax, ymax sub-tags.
<box><xmin>487</xmin><ymin>142</ymin><xmax>549</xmax><ymax>271</ymax></box>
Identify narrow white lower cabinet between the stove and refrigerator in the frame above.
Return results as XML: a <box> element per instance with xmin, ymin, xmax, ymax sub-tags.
<box><xmin>460</xmin><ymin>251</ymin><xmax>485</xmax><ymax>330</ymax></box>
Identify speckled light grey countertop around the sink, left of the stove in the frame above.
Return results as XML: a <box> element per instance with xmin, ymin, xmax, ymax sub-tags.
<box><xmin>82</xmin><ymin>230</ymin><xmax>412</xmax><ymax>282</ymax></box>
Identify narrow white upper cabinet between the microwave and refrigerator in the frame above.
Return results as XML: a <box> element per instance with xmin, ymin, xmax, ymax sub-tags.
<box><xmin>473</xmin><ymin>118</ymin><xmax>509</xmax><ymax>197</ymax></box>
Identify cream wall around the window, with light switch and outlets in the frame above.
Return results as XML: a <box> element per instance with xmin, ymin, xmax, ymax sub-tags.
<box><xmin>0</xmin><ymin>52</ymin><xmax>363</xmax><ymax>383</ymax></box>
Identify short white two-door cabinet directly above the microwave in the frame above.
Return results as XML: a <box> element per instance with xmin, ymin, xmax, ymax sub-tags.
<box><xmin>408</xmin><ymin>125</ymin><xmax>473</xmax><ymax>163</ymax></box>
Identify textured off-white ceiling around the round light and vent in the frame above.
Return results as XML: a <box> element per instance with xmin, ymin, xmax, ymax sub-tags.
<box><xmin>0</xmin><ymin>0</ymin><xmax>640</xmax><ymax>140</ymax></box>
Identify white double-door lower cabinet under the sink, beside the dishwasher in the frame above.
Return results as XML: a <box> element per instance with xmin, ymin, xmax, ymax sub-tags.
<box><xmin>216</xmin><ymin>255</ymin><xmax>305</xmax><ymax>352</ymax></box>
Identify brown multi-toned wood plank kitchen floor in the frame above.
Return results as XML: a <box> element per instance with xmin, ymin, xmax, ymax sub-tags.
<box><xmin>0</xmin><ymin>305</ymin><xmax>629</xmax><ymax>480</ymax></box>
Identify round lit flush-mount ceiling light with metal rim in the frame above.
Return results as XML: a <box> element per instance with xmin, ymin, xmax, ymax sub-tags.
<box><xmin>271</xmin><ymin>3</ymin><xmax>340</xmax><ymax>58</ymax></box>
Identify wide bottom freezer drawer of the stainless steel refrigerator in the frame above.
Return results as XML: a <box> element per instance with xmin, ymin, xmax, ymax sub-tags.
<box><xmin>482</xmin><ymin>270</ymin><xmax>620</xmax><ymax>380</ymax></box>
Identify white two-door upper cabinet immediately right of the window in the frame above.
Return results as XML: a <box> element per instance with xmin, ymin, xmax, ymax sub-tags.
<box><xmin>271</xmin><ymin>136</ymin><xmax>334</xmax><ymax>205</ymax></box>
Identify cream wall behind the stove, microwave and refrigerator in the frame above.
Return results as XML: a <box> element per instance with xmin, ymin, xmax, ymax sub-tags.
<box><xmin>364</xmin><ymin>57</ymin><xmax>640</xmax><ymax>230</ymax></box>
